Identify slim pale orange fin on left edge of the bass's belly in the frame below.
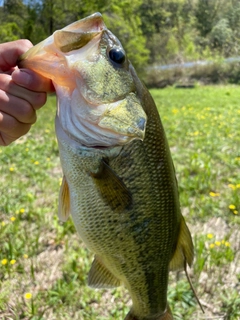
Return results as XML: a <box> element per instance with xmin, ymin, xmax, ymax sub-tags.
<box><xmin>58</xmin><ymin>176</ymin><xmax>70</xmax><ymax>222</ymax></box>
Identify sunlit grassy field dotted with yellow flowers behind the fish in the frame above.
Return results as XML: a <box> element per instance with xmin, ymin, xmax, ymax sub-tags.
<box><xmin>0</xmin><ymin>86</ymin><xmax>240</xmax><ymax>320</ymax></box>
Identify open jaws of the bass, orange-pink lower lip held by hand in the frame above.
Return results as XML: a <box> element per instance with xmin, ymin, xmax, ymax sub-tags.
<box><xmin>18</xmin><ymin>13</ymin><xmax>106</xmax><ymax>88</ymax></box>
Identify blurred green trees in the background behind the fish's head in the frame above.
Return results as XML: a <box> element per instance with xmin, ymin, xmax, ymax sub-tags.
<box><xmin>0</xmin><ymin>0</ymin><xmax>240</xmax><ymax>70</ymax></box>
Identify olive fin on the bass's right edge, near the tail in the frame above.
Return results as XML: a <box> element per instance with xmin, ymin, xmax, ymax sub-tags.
<box><xmin>169</xmin><ymin>217</ymin><xmax>194</xmax><ymax>271</ymax></box>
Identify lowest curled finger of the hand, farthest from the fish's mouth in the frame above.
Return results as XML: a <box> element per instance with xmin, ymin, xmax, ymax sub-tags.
<box><xmin>0</xmin><ymin>112</ymin><xmax>31</xmax><ymax>146</ymax></box>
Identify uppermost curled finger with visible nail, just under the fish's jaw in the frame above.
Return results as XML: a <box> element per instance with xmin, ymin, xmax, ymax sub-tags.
<box><xmin>12</xmin><ymin>69</ymin><xmax>55</xmax><ymax>92</ymax></box>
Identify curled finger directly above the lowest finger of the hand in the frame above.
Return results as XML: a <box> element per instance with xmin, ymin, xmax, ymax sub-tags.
<box><xmin>0</xmin><ymin>90</ymin><xmax>36</xmax><ymax>124</ymax></box>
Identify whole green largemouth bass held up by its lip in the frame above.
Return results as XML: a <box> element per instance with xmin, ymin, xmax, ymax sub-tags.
<box><xmin>19</xmin><ymin>13</ymin><xmax>194</xmax><ymax>320</ymax></box>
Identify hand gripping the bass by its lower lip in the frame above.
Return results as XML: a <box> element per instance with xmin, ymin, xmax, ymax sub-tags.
<box><xmin>0</xmin><ymin>40</ymin><xmax>54</xmax><ymax>146</ymax></box>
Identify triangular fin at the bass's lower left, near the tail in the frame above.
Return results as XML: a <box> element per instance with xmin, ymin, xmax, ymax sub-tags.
<box><xmin>88</xmin><ymin>256</ymin><xmax>121</xmax><ymax>288</ymax></box>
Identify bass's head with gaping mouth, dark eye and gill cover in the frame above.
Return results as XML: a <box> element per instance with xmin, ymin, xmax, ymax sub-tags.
<box><xmin>19</xmin><ymin>13</ymin><xmax>147</xmax><ymax>147</ymax></box>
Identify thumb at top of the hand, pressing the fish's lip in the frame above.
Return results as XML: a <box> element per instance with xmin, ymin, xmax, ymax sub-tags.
<box><xmin>0</xmin><ymin>39</ymin><xmax>32</xmax><ymax>72</ymax></box>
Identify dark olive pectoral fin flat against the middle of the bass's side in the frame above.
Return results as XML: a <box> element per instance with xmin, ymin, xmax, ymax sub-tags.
<box><xmin>91</xmin><ymin>160</ymin><xmax>132</xmax><ymax>212</ymax></box>
